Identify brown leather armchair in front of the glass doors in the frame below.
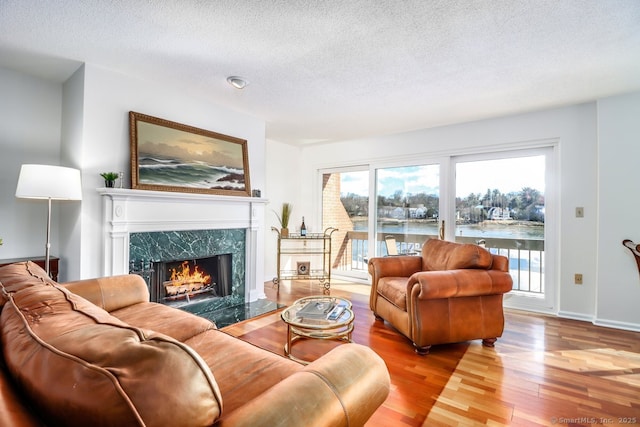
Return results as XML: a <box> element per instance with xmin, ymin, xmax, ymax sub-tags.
<box><xmin>369</xmin><ymin>239</ymin><xmax>513</xmax><ymax>354</ymax></box>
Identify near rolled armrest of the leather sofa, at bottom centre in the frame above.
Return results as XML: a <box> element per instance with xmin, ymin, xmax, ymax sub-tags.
<box><xmin>219</xmin><ymin>344</ymin><xmax>390</xmax><ymax>427</ymax></box>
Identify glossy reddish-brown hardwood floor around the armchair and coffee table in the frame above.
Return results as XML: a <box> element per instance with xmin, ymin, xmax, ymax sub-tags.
<box><xmin>224</xmin><ymin>281</ymin><xmax>640</xmax><ymax>427</ymax></box>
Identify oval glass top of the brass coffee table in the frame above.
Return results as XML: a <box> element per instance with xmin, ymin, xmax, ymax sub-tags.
<box><xmin>281</xmin><ymin>296</ymin><xmax>353</xmax><ymax>329</ymax></box>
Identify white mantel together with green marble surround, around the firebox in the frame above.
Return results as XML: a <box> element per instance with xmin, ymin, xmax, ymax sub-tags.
<box><xmin>98</xmin><ymin>188</ymin><xmax>267</xmax><ymax>305</ymax></box>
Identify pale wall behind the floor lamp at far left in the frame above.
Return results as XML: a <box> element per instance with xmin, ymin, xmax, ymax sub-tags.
<box><xmin>0</xmin><ymin>68</ymin><xmax>64</xmax><ymax>259</ymax></box>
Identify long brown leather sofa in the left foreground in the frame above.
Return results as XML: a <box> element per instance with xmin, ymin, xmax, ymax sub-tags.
<box><xmin>0</xmin><ymin>262</ymin><xmax>389</xmax><ymax>427</ymax></box>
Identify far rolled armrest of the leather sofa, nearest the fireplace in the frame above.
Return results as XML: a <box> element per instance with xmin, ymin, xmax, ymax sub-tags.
<box><xmin>61</xmin><ymin>274</ymin><xmax>149</xmax><ymax>312</ymax></box>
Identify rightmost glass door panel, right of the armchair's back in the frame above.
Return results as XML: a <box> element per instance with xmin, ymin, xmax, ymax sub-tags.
<box><xmin>452</xmin><ymin>149</ymin><xmax>554</xmax><ymax>308</ymax></box>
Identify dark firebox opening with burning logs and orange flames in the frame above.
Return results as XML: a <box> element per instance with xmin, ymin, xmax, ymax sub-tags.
<box><xmin>150</xmin><ymin>254</ymin><xmax>232</xmax><ymax>304</ymax></box>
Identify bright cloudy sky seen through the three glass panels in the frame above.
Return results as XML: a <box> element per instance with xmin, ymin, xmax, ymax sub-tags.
<box><xmin>341</xmin><ymin>156</ymin><xmax>545</xmax><ymax>197</ymax></box>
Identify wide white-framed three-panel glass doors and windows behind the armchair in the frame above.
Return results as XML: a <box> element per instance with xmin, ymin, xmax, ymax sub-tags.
<box><xmin>321</xmin><ymin>146</ymin><xmax>557</xmax><ymax>311</ymax></box>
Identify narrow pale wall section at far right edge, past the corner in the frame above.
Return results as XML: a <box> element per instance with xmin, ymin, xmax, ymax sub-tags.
<box><xmin>596</xmin><ymin>92</ymin><xmax>640</xmax><ymax>328</ymax></box>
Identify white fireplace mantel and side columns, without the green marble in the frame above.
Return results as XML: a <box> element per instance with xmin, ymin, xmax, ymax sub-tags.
<box><xmin>98</xmin><ymin>188</ymin><xmax>267</xmax><ymax>302</ymax></box>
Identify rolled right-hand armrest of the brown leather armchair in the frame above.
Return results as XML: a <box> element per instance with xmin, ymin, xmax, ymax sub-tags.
<box><xmin>407</xmin><ymin>269</ymin><xmax>513</xmax><ymax>300</ymax></box>
